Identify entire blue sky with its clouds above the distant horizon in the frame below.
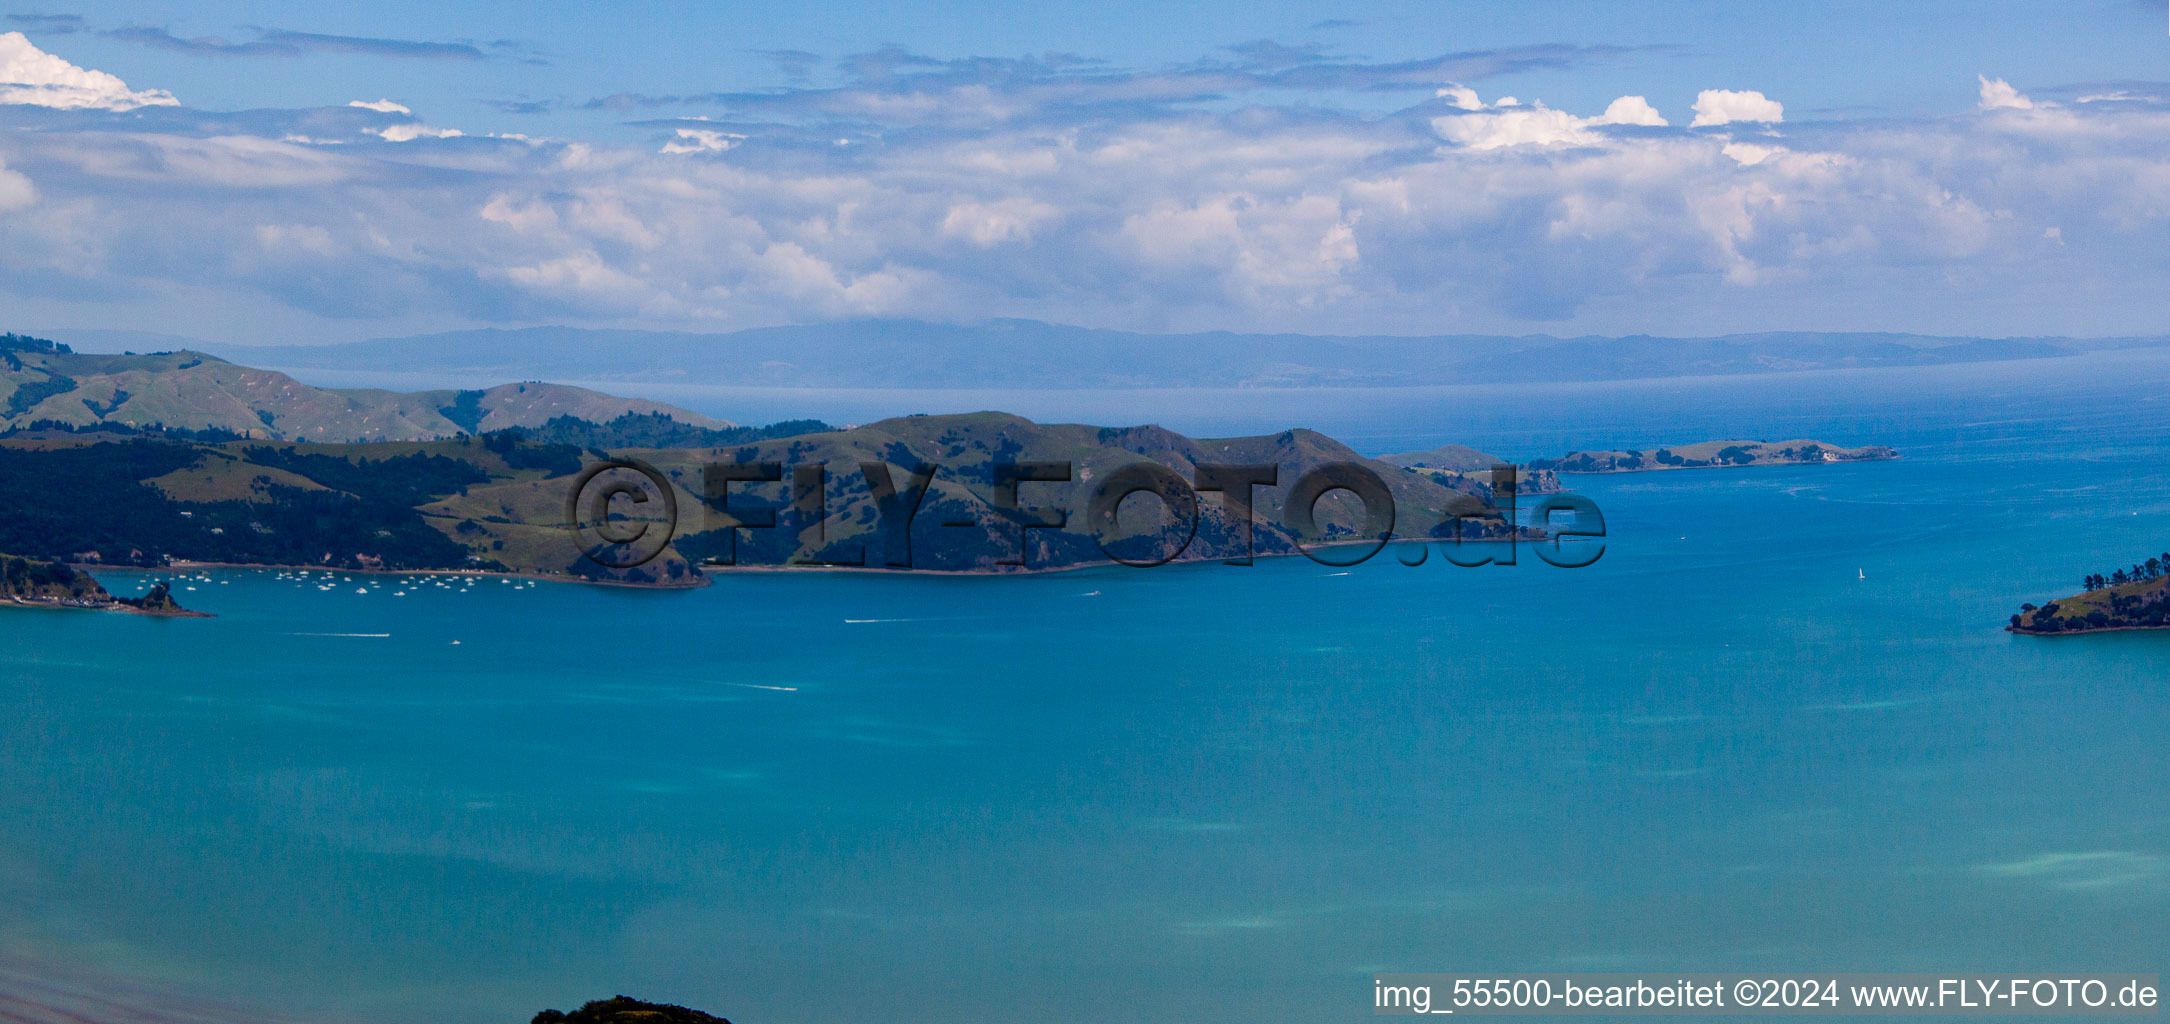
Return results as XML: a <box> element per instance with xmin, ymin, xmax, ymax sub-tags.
<box><xmin>0</xmin><ymin>0</ymin><xmax>2170</xmax><ymax>343</ymax></box>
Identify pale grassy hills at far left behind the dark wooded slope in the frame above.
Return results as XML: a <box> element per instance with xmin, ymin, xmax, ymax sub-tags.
<box><xmin>0</xmin><ymin>334</ymin><xmax>731</xmax><ymax>440</ymax></box>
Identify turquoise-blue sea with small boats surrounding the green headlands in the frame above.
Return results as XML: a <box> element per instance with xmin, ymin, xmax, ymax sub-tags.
<box><xmin>0</xmin><ymin>351</ymin><xmax>2170</xmax><ymax>1024</ymax></box>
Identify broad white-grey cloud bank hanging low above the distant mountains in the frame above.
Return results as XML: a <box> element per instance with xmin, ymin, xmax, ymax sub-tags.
<box><xmin>0</xmin><ymin>37</ymin><xmax>2170</xmax><ymax>341</ymax></box>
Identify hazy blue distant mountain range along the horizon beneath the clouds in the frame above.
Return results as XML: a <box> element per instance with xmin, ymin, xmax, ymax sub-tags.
<box><xmin>152</xmin><ymin>319</ymin><xmax>2170</xmax><ymax>388</ymax></box>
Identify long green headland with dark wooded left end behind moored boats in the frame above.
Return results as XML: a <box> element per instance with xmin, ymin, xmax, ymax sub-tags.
<box><xmin>0</xmin><ymin>412</ymin><xmax>1508</xmax><ymax>586</ymax></box>
